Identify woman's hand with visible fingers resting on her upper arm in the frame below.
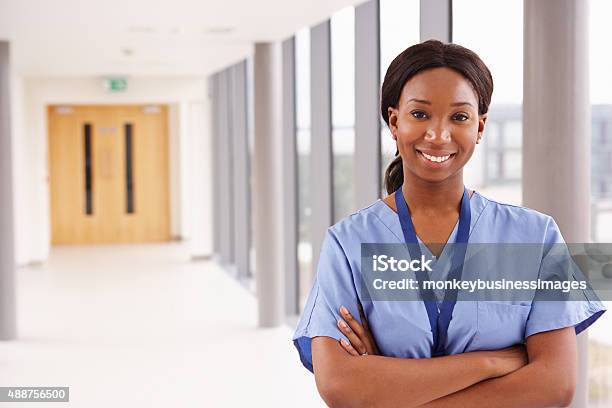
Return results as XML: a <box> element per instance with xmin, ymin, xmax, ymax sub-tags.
<box><xmin>338</xmin><ymin>305</ymin><xmax>380</xmax><ymax>356</ymax></box>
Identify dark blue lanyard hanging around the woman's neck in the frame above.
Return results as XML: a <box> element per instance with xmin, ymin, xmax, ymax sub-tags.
<box><xmin>395</xmin><ymin>187</ymin><xmax>471</xmax><ymax>357</ymax></box>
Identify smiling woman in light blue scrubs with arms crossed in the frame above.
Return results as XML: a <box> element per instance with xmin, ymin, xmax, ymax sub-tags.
<box><xmin>293</xmin><ymin>40</ymin><xmax>605</xmax><ymax>408</ymax></box>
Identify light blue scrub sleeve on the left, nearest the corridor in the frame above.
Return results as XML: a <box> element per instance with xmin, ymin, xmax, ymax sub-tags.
<box><xmin>293</xmin><ymin>229</ymin><xmax>359</xmax><ymax>372</ymax></box>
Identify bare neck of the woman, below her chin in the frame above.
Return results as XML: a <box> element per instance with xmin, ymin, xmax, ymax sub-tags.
<box><xmin>402</xmin><ymin>171</ymin><xmax>464</xmax><ymax>214</ymax></box>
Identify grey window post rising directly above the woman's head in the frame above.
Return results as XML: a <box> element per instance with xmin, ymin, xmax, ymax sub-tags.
<box><xmin>419</xmin><ymin>0</ymin><xmax>453</xmax><ymax>42</ymax></box>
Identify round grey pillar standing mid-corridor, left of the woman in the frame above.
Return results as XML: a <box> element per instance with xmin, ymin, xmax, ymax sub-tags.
<box><xmin>253</xmin><ymin>43</ymin><xmax>284</xmax><ymax>327</ymax></box>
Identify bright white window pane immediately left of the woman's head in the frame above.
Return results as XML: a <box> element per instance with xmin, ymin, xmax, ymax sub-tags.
<box><xmin>380</xmin><ymin>0</ymin><xmax>420</xmax><ymax>197</ymax></box>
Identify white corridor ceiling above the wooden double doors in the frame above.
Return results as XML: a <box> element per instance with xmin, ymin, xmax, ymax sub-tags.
<box><xmin>0</xmin><ymin>0</ymin><xmax>363</xmax><ymax>77</ymax></box>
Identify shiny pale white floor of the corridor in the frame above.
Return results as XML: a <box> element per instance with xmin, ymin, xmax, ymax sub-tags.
<box><xmin>0</xmin><ymin>244</ymin><xmax>324</xmax><ymax>408</ymax></box>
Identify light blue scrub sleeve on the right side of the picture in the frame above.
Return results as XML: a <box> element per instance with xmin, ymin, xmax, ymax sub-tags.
<box><xmin>525</xmin><ymin>218</ymin><xmax>606</xmax><ymax>338</ymax></box>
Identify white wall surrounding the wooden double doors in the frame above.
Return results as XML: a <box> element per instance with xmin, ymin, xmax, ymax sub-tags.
<box><xmin>13</xmin><ymin>78</ymin><xmax>212</xmax><ymax>264</ymax></box>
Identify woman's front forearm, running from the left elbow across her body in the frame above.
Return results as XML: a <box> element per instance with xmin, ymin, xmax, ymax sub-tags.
<box><xmin>313</xmin><ymin>337</ymin><xmax>519</xmax><ymax>408</ymax></box>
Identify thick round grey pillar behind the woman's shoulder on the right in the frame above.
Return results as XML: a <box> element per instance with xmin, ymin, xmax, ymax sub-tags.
<box><xmin>522</xmin><ymin>0</ymin><xmax>591</xmax><ymax>408</ymax></box>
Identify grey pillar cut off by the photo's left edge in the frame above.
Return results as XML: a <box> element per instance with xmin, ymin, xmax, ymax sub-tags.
<box><xmin>0</xmin><ymin>41</ymin><xmax>17</xmax><ymax>340</ymax></box>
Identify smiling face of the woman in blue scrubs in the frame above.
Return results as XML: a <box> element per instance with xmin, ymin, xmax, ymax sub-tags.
<box><xmin>388</xmin><ymin>67</ymin><xmax>486</xmax><ymax>183</ymax></box>
